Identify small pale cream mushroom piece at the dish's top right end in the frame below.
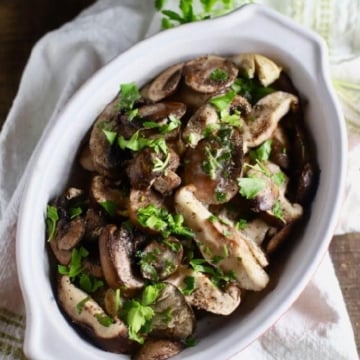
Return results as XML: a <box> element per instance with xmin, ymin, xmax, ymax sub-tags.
<box><xmin>230</xmin><ymin>53</ymin><xmax>282</xmax><ymax>86</ymax></box>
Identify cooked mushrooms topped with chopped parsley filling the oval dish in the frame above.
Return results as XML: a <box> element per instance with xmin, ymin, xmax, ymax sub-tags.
<box><xmin>46</xmin><ymin>53</ymin><xmax>319</xmax><ymax>360</ymax></box>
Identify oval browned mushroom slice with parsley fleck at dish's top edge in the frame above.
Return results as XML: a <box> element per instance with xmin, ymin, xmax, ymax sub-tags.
<box><xmin>184</xmin><ymin>55</ymin><xmax>238</xmax><ymax>93</ymax></box>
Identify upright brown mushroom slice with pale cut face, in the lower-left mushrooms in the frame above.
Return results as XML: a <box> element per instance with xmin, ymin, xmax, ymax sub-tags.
<box><xmin>99</xmin><ymin>225</ymin><xmax>144</xmax><ymax>293</ymax></box>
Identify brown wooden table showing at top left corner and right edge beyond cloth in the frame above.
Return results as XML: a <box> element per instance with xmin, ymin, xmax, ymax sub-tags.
<box><xmin>0</xmin><ymin>0</ymin><xmax>360</xmax><ymax>354</ymax></box>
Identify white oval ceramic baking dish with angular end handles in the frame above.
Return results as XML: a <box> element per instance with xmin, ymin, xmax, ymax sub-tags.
<box><xmin>17</xmin><ymin>5</ymin><xmax>346</xmax><ymax>360</ymax></box>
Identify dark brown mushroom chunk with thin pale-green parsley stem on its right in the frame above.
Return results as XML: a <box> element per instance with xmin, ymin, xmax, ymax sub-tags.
<box><xmin>126</xmin><ymin>148</ymin><xmax>180</xmax><ymax>190</ymax></box>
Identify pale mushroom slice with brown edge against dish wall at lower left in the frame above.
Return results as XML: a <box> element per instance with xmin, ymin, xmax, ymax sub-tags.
<box><xmin>58</xmin><ymin>276</ymin><xmax>134</xmax><ymax>354</ymax></box>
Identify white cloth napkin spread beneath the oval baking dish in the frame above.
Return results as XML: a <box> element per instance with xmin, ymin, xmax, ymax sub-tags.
<box><xmin>0</xmin><ymin>0</ymin><xmax>360</xmax><ymax>360</ymax></box>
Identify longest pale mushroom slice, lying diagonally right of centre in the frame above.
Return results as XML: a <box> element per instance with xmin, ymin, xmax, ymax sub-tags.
<box><xmin>175</xmin><ymin>186</ymin><xmax>269</xmax><ymax>291</ymax></box>
